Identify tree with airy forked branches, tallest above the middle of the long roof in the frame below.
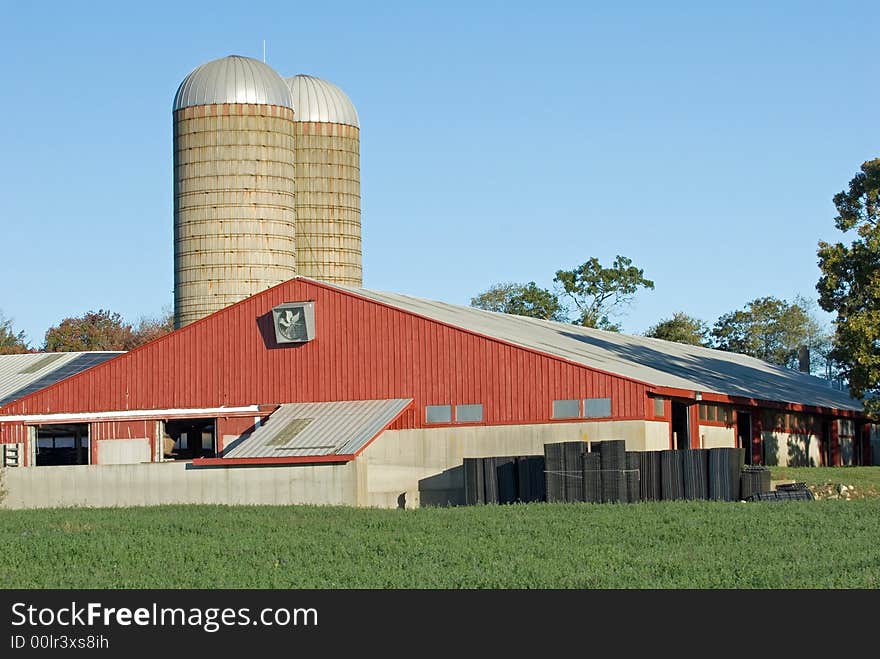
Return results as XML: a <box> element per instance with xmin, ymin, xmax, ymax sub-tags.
<box><xmin>553</xmin><ymin>255</ymin><xmax>654</xmax><ymax>332</ymax></box>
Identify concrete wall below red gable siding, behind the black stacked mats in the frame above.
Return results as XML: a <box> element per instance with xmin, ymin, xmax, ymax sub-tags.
<box><xmin>358</xmin><ymin>421</ymin><xmax>669</xmax><ymax>507</ymax></box>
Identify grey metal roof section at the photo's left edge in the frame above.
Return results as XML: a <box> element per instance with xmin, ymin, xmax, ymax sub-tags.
<box><xmin>0</xmin><ymin>352</ymin><xmax>122</xmax><ymax>407</ymax></box>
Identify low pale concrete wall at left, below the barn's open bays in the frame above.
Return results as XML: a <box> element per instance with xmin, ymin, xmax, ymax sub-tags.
<box><xmin>0</xmin><ymin>462</ymin><xmax>367</xmax><ymax>509</ymax></box>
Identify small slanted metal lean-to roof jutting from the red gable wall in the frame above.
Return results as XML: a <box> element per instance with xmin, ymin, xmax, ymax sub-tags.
<box><xmin>223</xmin><ymin>398</ymin><xmax>412</xmax><ymax>459</ymax></box>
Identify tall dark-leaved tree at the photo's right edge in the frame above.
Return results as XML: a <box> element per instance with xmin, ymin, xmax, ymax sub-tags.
<box><xmin>816</xmin><ymin>158</ymin><xmax>880</xmax><ymax>418</ymax></box>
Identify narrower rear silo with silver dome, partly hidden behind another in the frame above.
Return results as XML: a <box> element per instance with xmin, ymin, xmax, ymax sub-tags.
<box><xmin>287</xmin><ymin>75</ymin><xmax>363</xmax><ymax>286</ymax></box>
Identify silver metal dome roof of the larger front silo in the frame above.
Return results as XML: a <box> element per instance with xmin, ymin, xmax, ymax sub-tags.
<box><xmin>174</xmin><ymin>55</ymin><xmax>293</xmax><ymax>111</ymax></box>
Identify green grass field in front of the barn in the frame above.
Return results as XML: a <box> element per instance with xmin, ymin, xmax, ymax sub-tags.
<box><xmin>0</xmin><ymin>499</ymin><xmax>880</xmax><ymax>588</ymax></box>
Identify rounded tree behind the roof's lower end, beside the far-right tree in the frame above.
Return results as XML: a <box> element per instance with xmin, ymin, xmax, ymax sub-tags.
<box><xmin>712</xmin><ymin>297</ymin><xmax>824</xmax><ymax>368</ymax></box>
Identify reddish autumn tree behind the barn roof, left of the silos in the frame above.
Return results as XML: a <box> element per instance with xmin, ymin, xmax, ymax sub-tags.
<box><xmin>43</xmin><ymin>309</ymin><xmax>135</xmax><ymax>352</ymax></box>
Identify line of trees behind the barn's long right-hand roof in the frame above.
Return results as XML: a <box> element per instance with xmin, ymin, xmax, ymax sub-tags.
<box><xmin>471</xmin><ymin>158</ymin><xmax>880</xmax><ymax>417</ymax></box>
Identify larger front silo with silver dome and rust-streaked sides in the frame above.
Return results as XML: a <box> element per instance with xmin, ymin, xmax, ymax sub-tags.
<box><xmin>173</xmin><ymin>55</ymin><xmax>296</xmax><ymax>327</ymax></box>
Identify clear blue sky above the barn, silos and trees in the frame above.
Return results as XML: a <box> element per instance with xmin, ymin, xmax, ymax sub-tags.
<box><xmin>0</xmin><ymin>1</ymin><xmax>880</xmax><ymax>345</ymax></box>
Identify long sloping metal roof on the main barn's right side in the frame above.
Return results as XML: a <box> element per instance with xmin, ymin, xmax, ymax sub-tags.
<box><xmin>337</xmin><ymin>286</ymin><xmax>862</xmax><ymax>410</ymax></box>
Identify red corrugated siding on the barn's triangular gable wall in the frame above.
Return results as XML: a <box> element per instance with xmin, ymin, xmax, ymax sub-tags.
<box><xmin>0</xmin><ymin>279</ymin><xmax>646</xmax><ymax>428</ymax></box>
